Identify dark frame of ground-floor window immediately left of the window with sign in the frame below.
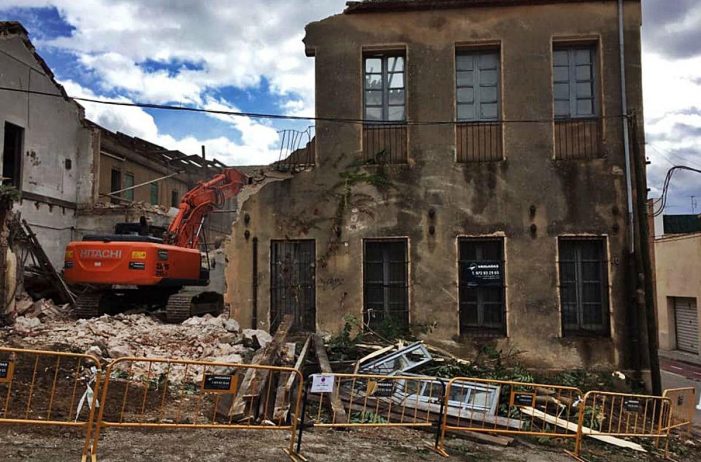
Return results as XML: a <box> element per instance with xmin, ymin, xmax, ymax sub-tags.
<box><xmin>363</xmin><ymin>238</ymin><xmax>409</xmax><ymax>328</ymax></box>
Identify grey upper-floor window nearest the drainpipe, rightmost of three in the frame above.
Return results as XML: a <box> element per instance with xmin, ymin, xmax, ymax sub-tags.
<box><xmin>553</xmin><ymin>46</ymin><xmax>597</xmax><ymax>118</ymax></box>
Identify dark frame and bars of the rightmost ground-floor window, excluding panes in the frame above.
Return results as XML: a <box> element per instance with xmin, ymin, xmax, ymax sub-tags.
<box><xmin>558</xmin><ymin>236</ymin><xmax>610</xmax><ymax>337</ymax></box>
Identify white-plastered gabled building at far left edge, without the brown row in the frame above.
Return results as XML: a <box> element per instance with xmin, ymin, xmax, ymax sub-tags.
<box><xmin>0</xmin><ymin>22</ymin><xmax>97</xmax><ymax>265</ymax></box>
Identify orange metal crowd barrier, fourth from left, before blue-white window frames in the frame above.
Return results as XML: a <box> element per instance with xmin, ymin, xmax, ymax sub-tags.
<box><xmin>439</xmin><ymin>377</ymin><xmax>582</xmax><ymax>450</ymax></box>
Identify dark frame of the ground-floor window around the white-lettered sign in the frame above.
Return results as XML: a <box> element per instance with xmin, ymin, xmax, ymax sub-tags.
<box><xmin>458</xmin><ymin>237</ymin><xmax>506</xmax><ymax>337</ymax></box>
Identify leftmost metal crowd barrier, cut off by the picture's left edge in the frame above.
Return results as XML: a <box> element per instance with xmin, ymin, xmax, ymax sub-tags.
<box><xmin>0</xmin><ymin>347</ymin><xmax>101</xmax><ymax>461</ymax></box>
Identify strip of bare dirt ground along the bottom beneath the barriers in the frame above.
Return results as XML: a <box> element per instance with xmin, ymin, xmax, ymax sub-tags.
<box><xmin>0</xmin><ymin>426</ymin><xmax>701</xmax><ymax>462</ymax></box>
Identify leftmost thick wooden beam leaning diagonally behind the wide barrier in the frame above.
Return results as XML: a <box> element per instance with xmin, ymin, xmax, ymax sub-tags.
<box><xmin>217</xmin><ymin>315</ymin><xmax>293</xmax><ymax>421</ymax></box>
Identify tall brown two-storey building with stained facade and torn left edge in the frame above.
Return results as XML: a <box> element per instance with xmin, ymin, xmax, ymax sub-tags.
<box><xmin>227</xmin><ymin>0</ymin><xmax>648</xmax><ymax>370</ymax></box>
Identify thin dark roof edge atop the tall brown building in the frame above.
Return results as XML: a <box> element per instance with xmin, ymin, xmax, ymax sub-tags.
<box><xmin>343</xmin><ymin>0</ymin><xmax>624</xmax><ymax>14</ymax></box>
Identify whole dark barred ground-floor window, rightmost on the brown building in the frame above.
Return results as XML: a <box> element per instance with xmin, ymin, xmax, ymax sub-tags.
<box><xmin>559</xmin><ymin>238</ymin><xmax>608</xmax><ymax>335</ymax></box>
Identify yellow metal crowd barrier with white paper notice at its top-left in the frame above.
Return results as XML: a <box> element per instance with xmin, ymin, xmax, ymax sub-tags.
<box><xmin>297</xmin><ymin>374</ymin><xmax>445</xmax><ymax>452</ymax></box>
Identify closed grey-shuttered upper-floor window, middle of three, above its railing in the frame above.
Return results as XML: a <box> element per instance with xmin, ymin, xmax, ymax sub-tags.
<box><xmin>455</xmin><ymin>51</ymin><xmax>499</xmax><ymax>121</ymax></box>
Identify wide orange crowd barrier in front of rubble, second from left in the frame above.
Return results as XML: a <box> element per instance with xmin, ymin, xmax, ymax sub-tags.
<box><xmin>92</xmin><ymin>358</ymin><xmax>303</xmax><ymax>459</ymax></box>
